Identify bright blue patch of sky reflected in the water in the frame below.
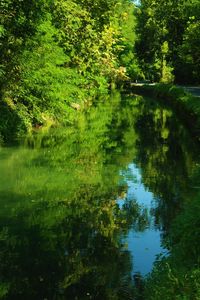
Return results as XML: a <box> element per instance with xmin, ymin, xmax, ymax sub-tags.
<box><xmin>118</xmin><ymin>163</ymin><xmax>167</xmax><ymax>276</ymax></box>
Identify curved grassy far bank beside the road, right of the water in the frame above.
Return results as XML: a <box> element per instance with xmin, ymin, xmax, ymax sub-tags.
<box><xmin>126</xmin><ymin>83</ymin><xmax>200</xmax><ymax>140</ymax></box>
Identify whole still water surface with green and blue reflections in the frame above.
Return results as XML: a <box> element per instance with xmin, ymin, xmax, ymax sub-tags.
<box><xmin>0</xmin><ymin>93</ymin><xmax>199</xmax><ymax>300</ymax></box>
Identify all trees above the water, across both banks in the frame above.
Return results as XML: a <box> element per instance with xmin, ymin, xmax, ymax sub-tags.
<box><xmin>0</xmin><ymin>0</ymin><xmax>200</xmax><ymax>142</ymax></box>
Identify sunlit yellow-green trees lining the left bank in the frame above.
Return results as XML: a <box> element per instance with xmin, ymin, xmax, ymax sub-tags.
<box><xmin>0</xmin><ymin>0</ymin><xmax>137</xmax><ymax>141</ymax></box>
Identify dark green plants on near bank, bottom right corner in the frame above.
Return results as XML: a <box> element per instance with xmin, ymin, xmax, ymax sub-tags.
<box><xmin>145</xmin><ymin>194</ymin><xmax>200</xmax><ymax>300</ymax></box>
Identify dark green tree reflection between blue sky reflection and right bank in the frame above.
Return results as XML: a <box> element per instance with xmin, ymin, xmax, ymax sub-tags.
<box><xmin>130</xmin><ymin>99</ymin><xmax>199</xmax><ymax>233</ymax></box>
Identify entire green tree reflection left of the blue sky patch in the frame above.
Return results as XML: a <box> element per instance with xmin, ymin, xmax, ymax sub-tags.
<box><xmin>0</xmin><ymin>94</ymin><xmax>144</xmax><ymax>299</ymax></box>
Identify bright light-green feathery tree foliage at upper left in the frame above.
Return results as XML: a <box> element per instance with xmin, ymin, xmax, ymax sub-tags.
<box><xmin>11</xmin><ymin>17</ymin><xmax>81</xmax><ymax>118</ymax></box>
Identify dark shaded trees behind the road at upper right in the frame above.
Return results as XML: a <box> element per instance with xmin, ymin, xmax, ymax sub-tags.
<box><xmin>136</xmin><ymin>0</ymin><xmax>200</xmax><ymax>84</ymax></box>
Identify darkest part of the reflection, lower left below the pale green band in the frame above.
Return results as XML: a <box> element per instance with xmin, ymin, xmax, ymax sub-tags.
<box><xmin>0</xmin><ymin>186</ymin><xmax>138</xmax><ymax>299</ymax></box>
